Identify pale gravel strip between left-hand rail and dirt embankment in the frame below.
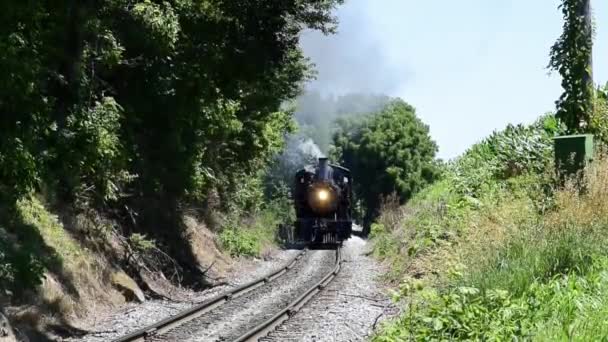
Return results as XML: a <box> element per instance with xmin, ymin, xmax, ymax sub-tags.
<box><xmin>56</xmin><ymin>250</ymin><xmax>300</xmax><ymax>342</ymax></box>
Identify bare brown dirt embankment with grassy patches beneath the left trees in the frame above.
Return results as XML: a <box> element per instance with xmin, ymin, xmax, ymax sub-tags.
<box><xmin>0</xmin><ymin>199</ymin><xmax>238</xmax><ymax>342</ymax></box>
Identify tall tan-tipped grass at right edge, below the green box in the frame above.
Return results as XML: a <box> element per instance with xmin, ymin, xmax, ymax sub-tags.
<box><xmin>467</xmin><ymin>158</ymin><xmax>608</xmax><ymax>294</ymax></box>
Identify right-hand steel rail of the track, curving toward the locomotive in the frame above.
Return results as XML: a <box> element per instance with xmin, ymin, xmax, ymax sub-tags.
<box><xmin>233</xmin><ymin>247</ymin><xmax>342</xmax><ymax>342</ymax></box>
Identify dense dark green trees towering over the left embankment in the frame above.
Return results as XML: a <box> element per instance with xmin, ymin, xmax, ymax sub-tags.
<box><xmin>0</xmin><ymin>0</ymin><xmax>342</xmax><ymax>292</ymax></box>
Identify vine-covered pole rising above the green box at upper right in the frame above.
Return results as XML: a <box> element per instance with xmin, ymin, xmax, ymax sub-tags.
<box><xmin>549</xmin><ymin>0</ymin><xmax>594</xmax><ymax>133</ymax></box>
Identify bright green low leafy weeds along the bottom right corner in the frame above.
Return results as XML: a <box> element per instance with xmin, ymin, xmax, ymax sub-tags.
<box><xmin>373</xmin><ymin>258</ymin><xmax>608</xmax><ymax>342</ymax></box>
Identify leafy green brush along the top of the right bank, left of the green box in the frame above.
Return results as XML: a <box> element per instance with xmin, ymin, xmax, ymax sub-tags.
<box><xmin>371</xmin><ymin>115</ymin><xmax>557</xmax><ymax>280</ymax></box>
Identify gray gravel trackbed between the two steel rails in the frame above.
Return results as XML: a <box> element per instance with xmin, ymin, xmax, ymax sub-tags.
<box><xmin>146</xmin><ymin>250</ymin><xmax>340</xmax><ymax>342</ymax></box>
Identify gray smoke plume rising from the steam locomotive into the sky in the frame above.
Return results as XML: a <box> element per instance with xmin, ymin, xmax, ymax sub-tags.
<box><xmin>270</xmin><ymin>0</ymin><xmax>409</xmax><ymax>192</ymax></box>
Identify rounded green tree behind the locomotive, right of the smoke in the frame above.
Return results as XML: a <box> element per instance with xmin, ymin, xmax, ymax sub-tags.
<box><xmin>332</xmin><ymin>99</ymin><xmax>437</xmax><ymax>225</ymax></box>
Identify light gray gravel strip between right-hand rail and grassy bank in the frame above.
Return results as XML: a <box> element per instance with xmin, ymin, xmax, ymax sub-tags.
<box><xmin>260</xmin><ymin>237</ymin><xmax>398</xmax><ymax>342</ymax></box>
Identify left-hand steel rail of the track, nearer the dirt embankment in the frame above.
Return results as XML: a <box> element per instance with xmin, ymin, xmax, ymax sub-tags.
<box><xmin>113</xmin><ymin>249</ymin><xmax>307</xmax><ymax>342</ymax></box>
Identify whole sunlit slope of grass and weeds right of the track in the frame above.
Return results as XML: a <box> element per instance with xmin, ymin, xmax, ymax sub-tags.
<box><xmin>372</xmin><ymin>154</ymin><xmax>608</xmax><ymax>342</ymax></box>
